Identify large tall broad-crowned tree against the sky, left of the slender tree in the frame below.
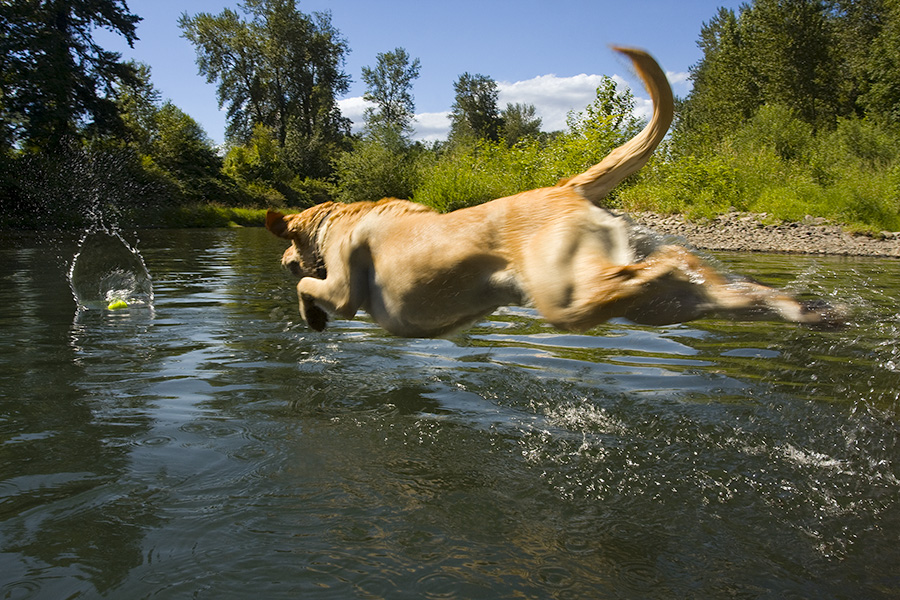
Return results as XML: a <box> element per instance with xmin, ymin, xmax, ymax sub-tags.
<box><xmin>179</xmin><ymin>0</ymin><xmax>350</xmax><ymax>177</ymax></box>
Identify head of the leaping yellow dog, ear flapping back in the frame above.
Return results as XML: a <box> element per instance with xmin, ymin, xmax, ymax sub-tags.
<box><xmin>266</xmin><ymin>202</ymin><xmax>333</xmax><ymax>279</ymax></box>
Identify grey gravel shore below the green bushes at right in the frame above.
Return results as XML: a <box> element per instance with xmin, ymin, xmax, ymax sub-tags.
<box><xmin>630</xmin><ymin>212</ymin><xmax>900</xmax><ymax>258</ymax></box>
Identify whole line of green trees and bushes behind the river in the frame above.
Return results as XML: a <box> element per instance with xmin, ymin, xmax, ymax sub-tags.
<box><xmin>0</xmin><ymin>0</ymin><xmax>900</xmax><ymax>234</ymax></box>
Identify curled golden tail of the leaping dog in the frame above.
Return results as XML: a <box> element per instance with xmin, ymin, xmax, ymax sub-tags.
<box><xmin>560</xmin><ymin>46</ymin><xmax>675</xmax><ymax>204</ymax></box>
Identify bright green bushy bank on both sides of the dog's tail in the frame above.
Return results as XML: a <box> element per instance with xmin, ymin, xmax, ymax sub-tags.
<box><xmin>414</xmin><ymin>106</ymin><xmax>900</xmax><ymax>232</ymax></box>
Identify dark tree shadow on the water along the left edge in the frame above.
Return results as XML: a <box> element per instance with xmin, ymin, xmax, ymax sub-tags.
<box><xmin>0</xmin><ymin>234</ymin><xmax>162</xmax><ymax>598</ymax></box>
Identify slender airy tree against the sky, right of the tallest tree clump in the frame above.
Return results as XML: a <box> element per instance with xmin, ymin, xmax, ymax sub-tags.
<box><xmin>362</xmin><ymin>48</ymin><xmax>420</xmax><ymax>133</ymax></box>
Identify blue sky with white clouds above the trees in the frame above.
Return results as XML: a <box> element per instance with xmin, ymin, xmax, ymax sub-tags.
<box><xmin>96</xmin><ymin>0</ymin><xmax>743</xmax><ymax>143</ymax></box>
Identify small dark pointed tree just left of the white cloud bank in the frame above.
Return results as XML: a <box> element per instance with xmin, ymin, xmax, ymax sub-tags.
<box><xmin>450</xmin><ymin>73</ymin><xmax>503</xmax><ymax>143</ymax></box>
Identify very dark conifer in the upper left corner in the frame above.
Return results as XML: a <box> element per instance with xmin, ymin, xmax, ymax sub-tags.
<box><xmin>0</xmin><ymin>0</ymin><xmax>140</xmax><ymax>150</ymax></box>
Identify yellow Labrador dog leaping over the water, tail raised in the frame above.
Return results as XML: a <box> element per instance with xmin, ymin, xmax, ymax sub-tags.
<box><xmin>266</xmin><ymin>48</ymin><xmax>835</xmax><ymax>337</ymax></box>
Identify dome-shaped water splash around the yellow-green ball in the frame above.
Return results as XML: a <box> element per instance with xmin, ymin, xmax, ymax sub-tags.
<box><xmin>69</xmin><ymin>226</ymin><xmax>153</xmax><ymax>311</ymax></box>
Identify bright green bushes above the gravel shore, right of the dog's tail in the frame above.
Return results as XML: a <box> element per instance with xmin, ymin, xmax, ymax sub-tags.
<box><xmin>616</xmin><ymin>106</ymin><xmax>900</xmax><ymax>231</ymax></box>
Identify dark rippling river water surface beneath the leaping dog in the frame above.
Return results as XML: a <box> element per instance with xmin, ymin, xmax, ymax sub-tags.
<box><xmin>0</xmin><ymin>230</ymin><xmax>900</xmax><ymax>599</ymax></box>
